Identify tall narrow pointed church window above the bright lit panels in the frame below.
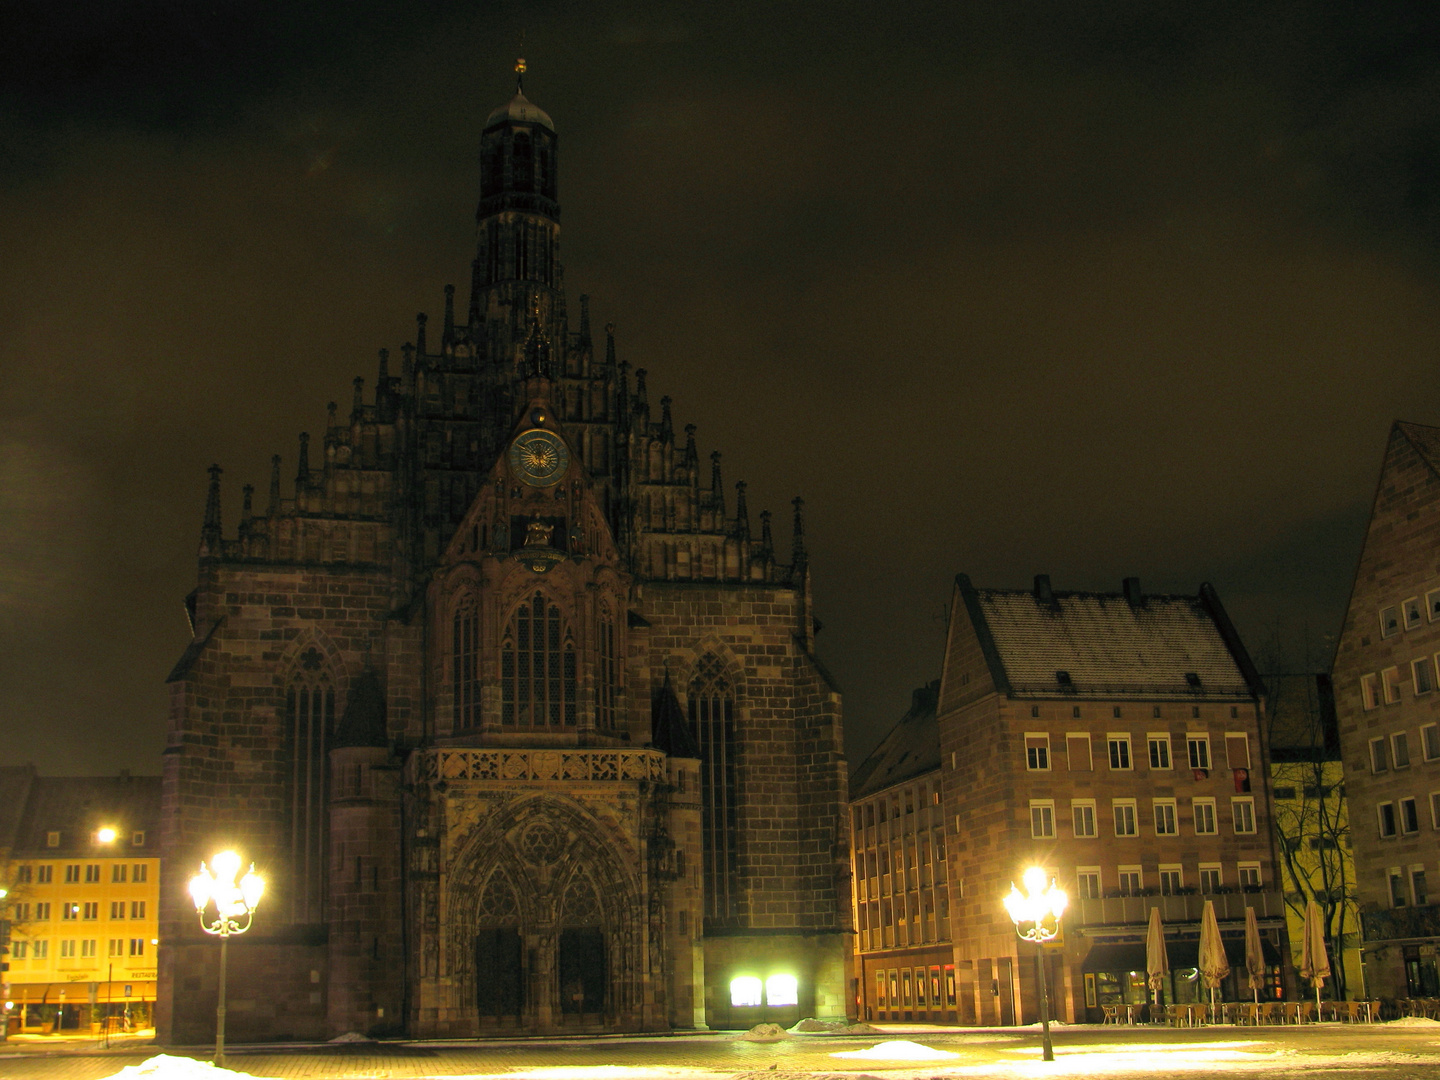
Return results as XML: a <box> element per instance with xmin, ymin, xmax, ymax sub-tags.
<box><xmin>690</xmin><ymin>655</ymin><xmax>740</xmax><ymax>919</ymax></box>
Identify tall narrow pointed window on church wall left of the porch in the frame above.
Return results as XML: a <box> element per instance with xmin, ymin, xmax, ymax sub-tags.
<box><xmin>285</xmin><ymin>647</ymin><xmax>336</xmax><ymax>923</ymax></box>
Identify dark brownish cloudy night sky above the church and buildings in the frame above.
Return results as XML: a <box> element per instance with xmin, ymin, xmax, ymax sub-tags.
<box><xmin>0</xmin><ymin>0</ymin><xmax>1440</xmax><ymax>773</ymax></box>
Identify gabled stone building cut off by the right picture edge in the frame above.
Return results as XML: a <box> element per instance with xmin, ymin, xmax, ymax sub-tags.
<box><xmin>1332</xmin><ymin>422</ymin><xmax>1440</xmax><ymax>998</ymax></box>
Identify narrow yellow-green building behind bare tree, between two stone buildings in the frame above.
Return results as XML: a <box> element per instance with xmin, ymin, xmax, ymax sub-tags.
<box><xmin>1263</xmin><ymin>674</ymin><xmax>1364</xmax><ymax>998</ymax></box>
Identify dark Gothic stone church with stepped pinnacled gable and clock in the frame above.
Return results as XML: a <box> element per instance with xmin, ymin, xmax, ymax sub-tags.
<box><xmin>158</xmin><ymin>74</ymin><xmax>851</xmax><ymax>1043</ymax></box>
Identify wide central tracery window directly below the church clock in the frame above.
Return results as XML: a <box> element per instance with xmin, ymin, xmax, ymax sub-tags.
<box><xmin>500</xmin><ymin>592</ymin><xmax>576</xmax><ymax>729</ymax></box>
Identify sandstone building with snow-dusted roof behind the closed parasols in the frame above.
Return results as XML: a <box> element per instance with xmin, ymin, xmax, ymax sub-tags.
<box><xmin>937</xmin><ymin>575</ymin><xmax>1284</xmax><ymax>1024</ymax></box>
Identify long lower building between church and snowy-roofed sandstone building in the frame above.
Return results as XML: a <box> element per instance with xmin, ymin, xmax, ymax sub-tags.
<box><xmin>850</xmin><ymin>681</ymin><xmax>958</xmax><ymax>1024</ymax></box>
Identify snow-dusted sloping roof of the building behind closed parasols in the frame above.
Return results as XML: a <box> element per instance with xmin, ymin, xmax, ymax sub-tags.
<box><xmin>956</xmin><ymin>575</ymin><xmax>1263</xmax><ymax>700</ymax></box>
